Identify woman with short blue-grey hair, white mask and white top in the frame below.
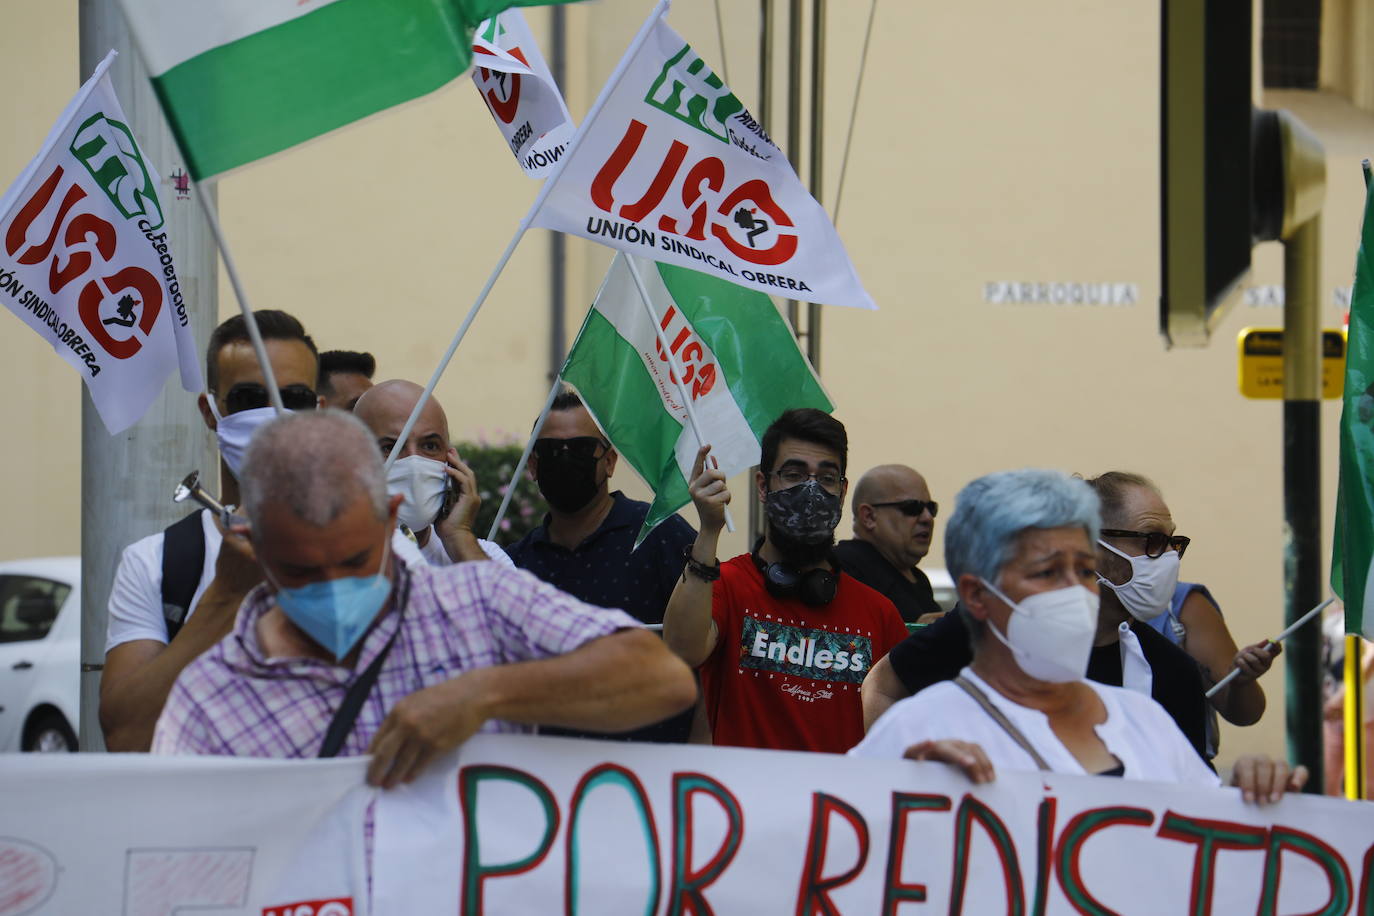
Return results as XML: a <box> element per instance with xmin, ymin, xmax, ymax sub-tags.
<box><xmin>849</xmin><ymin>470</ymin><xmax>1307</xmax><ymax>801</ymax></box>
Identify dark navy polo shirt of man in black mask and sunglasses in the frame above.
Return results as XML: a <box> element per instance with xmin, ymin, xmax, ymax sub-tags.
<box><xmin>506</xmin><ymin>490</ymin><xmax>697</xmax><ymax>744</ymax></box>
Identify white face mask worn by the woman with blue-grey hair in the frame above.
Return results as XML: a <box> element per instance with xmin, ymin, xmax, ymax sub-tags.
<box><xmin>982</xmin><ymin>580</ymin><xmax>1098</xmax><ymax>684</ymax></box>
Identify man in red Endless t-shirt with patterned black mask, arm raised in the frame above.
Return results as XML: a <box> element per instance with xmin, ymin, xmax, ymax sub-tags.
<box><xmin>664</xmin><ymin>408</ymin><xmax>907</xmax><ymax>754</ymax></box>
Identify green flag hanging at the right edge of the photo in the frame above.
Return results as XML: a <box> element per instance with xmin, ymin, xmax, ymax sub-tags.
<box><xmin>1331</xmin><ymin>175</ymin><xmax>1374</xmax><ymax>639</ymax></box>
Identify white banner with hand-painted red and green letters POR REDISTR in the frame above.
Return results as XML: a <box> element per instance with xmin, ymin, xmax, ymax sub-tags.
<box><xmin>374</xmin><ymin>735</ymin><xmax>1374</xmax><ymax>916</ymax></box>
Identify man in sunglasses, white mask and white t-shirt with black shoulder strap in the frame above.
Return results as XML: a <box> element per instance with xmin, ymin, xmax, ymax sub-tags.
<box><xmin>100</xmin><ymin>309</ymin><xmax>320</xmax><ymax>751</ymax></box>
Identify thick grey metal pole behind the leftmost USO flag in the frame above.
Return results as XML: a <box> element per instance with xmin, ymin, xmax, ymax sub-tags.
<box><xmin>73</xmin><ymin>0</ymin><xmax>218</xmax><ymax>751</ymax></box>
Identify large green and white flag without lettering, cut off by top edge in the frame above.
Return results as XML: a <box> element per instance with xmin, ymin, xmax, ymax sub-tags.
<box><xmin>122</xmin><ymin>0</ymin><xmax>585</xmax><ymax>179</ymax></box>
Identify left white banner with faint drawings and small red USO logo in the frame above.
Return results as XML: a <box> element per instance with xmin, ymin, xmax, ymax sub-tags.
<box><xmin>0</xmin><ymin>754</ymin><xmax>375</xmax><ymax>916</ymax></box>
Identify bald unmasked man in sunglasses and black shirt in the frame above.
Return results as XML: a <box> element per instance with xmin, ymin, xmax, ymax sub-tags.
<box><xmin>834</xmin><ymin>464</ymin><xmax>943</xmax><ymax>623</ymax></box>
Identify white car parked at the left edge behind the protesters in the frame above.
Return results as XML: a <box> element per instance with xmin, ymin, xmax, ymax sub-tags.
<box><xmin>0</xmin><ymin>556</ymin><xmax>81</xmax><ymax>753</ymax></box>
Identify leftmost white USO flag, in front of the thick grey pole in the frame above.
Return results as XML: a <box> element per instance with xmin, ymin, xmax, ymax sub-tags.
<box><xmin>0</xmin><ymin>51</ymin><xmax>201</xmax><ymax>434</ymax></box>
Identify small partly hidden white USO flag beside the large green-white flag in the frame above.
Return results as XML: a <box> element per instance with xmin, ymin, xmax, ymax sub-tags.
<box><xmin>473</xmin><ymin>10</ymin><xmax>576</xmax><ymax>179</ymax></box>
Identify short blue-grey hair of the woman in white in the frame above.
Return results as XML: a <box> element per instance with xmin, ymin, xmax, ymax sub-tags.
<box><xmin>945</xmin><ymin>468</ymin><xmax>1102</xmax><ymax>584</ymax></box>
